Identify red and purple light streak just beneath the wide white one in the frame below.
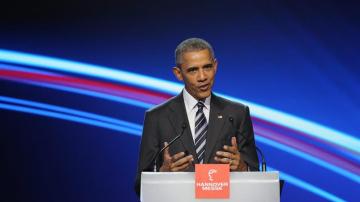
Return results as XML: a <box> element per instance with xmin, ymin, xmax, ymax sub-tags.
<box><xmin>0</xmin><ymin>64</ymin><xmax>360</xmax><ymax>167</ymax></box>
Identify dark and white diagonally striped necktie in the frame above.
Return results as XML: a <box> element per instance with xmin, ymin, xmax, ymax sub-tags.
<box><xmin>195</xmin><ymin>101</ymin><xmax>208</xmax><ymax>163</ymax></box>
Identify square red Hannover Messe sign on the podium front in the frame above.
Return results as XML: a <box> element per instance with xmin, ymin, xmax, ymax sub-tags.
<box><xmin>195</xmin><ymin>164</ymin><xmax>230</xmax><ymax>199</ymax></box>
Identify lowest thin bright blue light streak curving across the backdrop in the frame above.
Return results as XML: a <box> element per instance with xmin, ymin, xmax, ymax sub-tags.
<box><xmin>0</xmin><ymin>100</ymin><xmax>345</xmax><ymax>202</ymax></box>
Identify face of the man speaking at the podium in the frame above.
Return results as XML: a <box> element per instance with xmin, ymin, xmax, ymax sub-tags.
<box><xmin>173</xmin><ymin>49</ymin><xmax>217</xmax><ymax>100</ymax></box>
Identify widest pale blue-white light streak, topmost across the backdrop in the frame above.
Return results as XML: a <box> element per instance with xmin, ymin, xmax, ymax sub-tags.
<box><xmin>0</xmin><ymin>49</ymin><xmax>360</xmax><ymax>153</ymax></box>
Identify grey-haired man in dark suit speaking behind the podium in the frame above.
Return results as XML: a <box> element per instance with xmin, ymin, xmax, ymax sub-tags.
<box><xmin>135</xmin><ymin>38</ymin><xmax>259</xmax><ymax>195</ymax></box>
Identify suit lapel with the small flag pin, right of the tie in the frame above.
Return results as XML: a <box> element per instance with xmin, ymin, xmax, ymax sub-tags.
<box><xmin>204</xmin><ymin>94</ymin><xmax>226</xmax><ymax>163</ymax></box>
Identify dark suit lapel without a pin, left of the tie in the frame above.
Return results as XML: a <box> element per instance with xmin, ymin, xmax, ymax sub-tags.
<box><xmin>168</xmin><ymin>93</ymin><xmax>198</xmax><ymax>163</ymax></box>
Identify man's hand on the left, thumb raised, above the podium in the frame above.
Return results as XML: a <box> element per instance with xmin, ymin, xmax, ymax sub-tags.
<box><xmin>160</xmin><ymin>142</ymin><xmax>194</xmax><ymax>172</ymax></box>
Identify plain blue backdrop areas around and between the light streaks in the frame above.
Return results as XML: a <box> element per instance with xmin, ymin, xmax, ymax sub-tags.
<box><xmin>0</xmin><ymin>0</ymin><xmax>360</xmax><ymax>201</ymax></box>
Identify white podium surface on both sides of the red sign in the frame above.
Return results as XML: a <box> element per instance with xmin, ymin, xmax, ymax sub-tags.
<box><xmin>140</xmin><ymin>171</ymin><xmax>280</xmax><ymax>202</ymax></box>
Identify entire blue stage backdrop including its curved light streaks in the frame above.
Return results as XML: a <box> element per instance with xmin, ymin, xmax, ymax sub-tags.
<box><xmin>0</xmin><ymin>0</ymin><xmax>360</xmax><ymax>202</ymax></box>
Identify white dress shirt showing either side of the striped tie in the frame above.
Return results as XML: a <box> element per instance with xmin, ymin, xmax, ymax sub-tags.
<box><xmin>183</xmin><ymin>88</ymin><xmax>211</xmax><ymax>142</ymax></box>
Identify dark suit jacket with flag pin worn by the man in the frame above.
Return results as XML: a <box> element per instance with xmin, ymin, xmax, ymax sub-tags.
<box><xmin>135</xmin><ymin>93</ymin><xmax>259</xmax><ymax>195</ymax></box>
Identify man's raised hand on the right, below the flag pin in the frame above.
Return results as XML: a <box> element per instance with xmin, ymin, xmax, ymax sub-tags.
<box><xmin>214</xmin><ymin>137</ymin><xmax>247</xmax><ymax>171</ymax></box>
